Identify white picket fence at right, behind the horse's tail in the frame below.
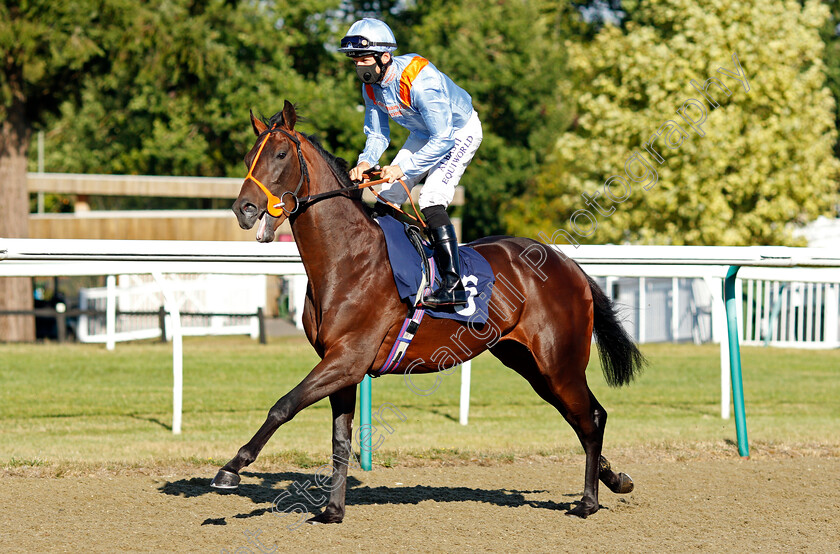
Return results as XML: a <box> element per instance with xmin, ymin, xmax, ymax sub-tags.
<box><xmin>587</xmin><ymin>266</ymin><xmax>840</xmax><ymax>348</ymax></box>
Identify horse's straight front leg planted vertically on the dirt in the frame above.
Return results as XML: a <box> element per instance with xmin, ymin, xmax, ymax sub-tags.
<box><xmin>307</xmin><ymin>385</ymin><xmax>356</xmax><ymax>523</ymax></box>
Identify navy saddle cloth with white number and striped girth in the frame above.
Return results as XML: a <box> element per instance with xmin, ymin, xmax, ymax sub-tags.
<box><xmin>375</xmin><ymin>216</ymin><xmax>495</xmax><ymax>376</ymax></box>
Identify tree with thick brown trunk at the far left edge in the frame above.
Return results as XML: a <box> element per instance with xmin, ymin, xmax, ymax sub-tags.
<box><xmin>0</xmin><ymin>0</ymin><xmax>123</xmax><ymax>341</ymax></box>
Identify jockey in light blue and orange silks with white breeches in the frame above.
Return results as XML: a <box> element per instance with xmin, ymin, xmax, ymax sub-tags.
<box><xmin>339</xmin><ymin>18</ymin><xmax>483</xmax><ymax>308</ymax></box>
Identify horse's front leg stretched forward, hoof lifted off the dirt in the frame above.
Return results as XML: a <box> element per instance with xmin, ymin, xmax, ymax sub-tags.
<box><xmin>210</xmin><ymin>355</ymin><xmax>366</xmax><ymax>489</ymax></box>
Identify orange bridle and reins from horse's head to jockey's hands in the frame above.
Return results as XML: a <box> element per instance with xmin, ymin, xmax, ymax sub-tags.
<box><xmin>245</xmin><ymin>124</ymin><xmax>426</xmax><ymax>228</ymax></box>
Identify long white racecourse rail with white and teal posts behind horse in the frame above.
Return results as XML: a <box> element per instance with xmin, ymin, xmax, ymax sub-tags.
<box><xmin>0</xmin><ymin>238</ymin><xmax>840</xmax><ymax>458</ymax></box>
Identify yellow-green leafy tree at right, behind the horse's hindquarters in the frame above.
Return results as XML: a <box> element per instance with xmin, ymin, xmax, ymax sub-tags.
<box><xmin>507</xmin><ymin>0</ymin><xmax>838</xmax><ymax>245</ymax></box>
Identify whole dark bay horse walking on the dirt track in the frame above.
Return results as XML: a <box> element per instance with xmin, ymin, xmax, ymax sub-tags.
<box><xmin>211</xmin><ymin>101</ymin><xmax>645</xmax><ymax>523</ymax></box>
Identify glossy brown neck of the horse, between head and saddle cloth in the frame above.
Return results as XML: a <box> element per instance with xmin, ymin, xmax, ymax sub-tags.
<box><xmin>292</xmin><ymin>151</ymin><xmax>384</xmax><ymax>293</ymax></box>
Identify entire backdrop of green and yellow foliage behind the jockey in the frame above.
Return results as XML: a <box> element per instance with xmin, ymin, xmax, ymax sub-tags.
<box><xmin>13</xmin><ymin>0</ymin><xmax>840</xmax><ymax>240</ymax></box>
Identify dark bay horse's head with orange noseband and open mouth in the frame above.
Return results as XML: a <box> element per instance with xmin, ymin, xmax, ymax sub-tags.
<box><xmin>232</xmin><ymin>100</ymin><xmax>309</xmax><ymax>242</ymax></box>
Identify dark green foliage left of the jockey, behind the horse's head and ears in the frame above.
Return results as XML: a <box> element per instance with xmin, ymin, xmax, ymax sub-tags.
<box><xmin>37</xmin><ymin>0</ymin><xmax>362</xmax><ymax>181</ymax></box>
